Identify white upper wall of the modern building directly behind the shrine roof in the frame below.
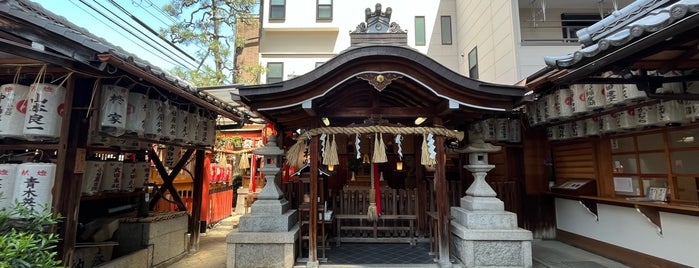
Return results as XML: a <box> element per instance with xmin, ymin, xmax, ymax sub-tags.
<box><xmin>260</xmin><ymin>0</ymin><xmax>459</xmax><ymax>83</ymax></box>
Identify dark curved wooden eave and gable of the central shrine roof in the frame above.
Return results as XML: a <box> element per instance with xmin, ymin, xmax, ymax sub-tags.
<box><xmin>238</xmin><ymin>46</ymin><xmax>524</xmax><ymax>131</ymax></box>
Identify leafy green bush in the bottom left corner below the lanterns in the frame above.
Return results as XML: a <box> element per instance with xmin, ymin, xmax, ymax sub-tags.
<box><xmin>0</xmin><ymin>202</ymin><xmax>61</xmax><ymax>268</ymax></box>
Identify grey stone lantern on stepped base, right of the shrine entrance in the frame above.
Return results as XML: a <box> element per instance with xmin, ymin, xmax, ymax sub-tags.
<box><xmin>451</xmin><ymin>139</ymin><xmax>532</xmax><ymax>267</ymax></box>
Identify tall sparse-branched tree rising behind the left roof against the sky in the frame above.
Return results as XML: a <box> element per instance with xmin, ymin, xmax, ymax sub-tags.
<box><xmin>161</xmin><ymin>0</ymin><xmax>257</xmax><ymax>86</ymax></box>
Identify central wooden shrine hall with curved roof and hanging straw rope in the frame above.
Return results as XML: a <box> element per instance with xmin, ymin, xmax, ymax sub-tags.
<box><xmin>238</xmin><ymin>7</ymin><xmax>524</xmax><ymax>262</ymax></box>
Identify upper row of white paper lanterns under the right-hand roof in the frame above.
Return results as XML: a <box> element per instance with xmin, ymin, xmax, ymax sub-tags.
<box><xmin>527</xmin><ymin>84</ymin><xmax>646</xmax><ymax>126</ymax></box>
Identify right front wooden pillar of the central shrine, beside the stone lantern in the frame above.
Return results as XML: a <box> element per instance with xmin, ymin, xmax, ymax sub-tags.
<box><xmin>434</xmin><ymin>122</ymin><xmax>451</xmax><ymax>267</ymax></box>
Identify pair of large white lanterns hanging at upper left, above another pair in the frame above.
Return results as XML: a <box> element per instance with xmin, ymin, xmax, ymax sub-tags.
<box><xmin>0</xmin><ymin>83</ymin><xmax>66</xmax><ymax>141</ymax></box>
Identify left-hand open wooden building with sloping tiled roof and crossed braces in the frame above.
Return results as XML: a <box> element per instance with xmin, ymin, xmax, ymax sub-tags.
<box><xmin>0</xmin><ymin>0</ymin><xmax>241</xmax><ymax>267</ymax></box>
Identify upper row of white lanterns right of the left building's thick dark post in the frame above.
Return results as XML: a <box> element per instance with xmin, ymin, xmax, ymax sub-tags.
<box><xmin>98</xmin><ymin>85</ymin><xmax>216</xmax><ymax>146</ymax></box>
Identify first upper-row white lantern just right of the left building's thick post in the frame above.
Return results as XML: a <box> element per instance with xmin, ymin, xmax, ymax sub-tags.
<box><xmin>99</xmin><ymin>85</ymin><xmax>129</xmax><ymax>137</ymax></box>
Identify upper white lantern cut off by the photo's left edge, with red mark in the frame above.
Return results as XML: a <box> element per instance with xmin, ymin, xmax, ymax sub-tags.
<box><xmin>0</xmin><ymin>84</ymin><xmax>29</xmax><ymax>139</ymax></box>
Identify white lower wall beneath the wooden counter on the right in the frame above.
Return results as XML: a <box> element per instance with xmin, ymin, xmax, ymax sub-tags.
<box><xmin>556</xmin><ymin>198</ymin><xmax>699</xmax><ymax>267</ymax></box>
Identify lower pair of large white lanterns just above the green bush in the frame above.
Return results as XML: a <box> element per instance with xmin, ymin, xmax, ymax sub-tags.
<box><xmin>0</xmin><ymin>162</ymin><xmax>56</xmax><ymax>211</ymax></box>
